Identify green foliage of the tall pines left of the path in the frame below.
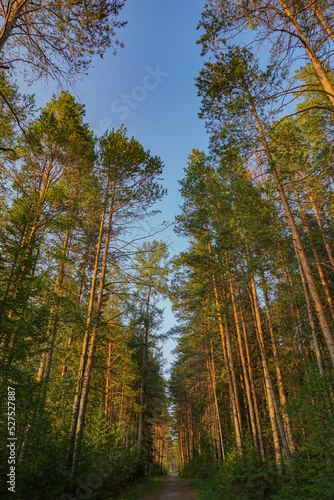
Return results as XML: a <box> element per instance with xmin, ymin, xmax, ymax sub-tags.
<box><xmin>0</xmin><ymin>88</ymin><xmax>169</xmax><ymax>499</ymax></box>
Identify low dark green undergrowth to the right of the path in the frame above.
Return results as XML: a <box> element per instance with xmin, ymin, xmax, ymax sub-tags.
<box><xmin>179</xmin><ymin>451</ymin><xmax>334</xmax><ymax>500</ymax></box>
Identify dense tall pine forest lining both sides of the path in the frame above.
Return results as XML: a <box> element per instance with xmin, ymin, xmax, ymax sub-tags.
<box><xmin>0</xmin><ymin>0</ymin><xmax>334</xmax><ymax>500</ymax></box>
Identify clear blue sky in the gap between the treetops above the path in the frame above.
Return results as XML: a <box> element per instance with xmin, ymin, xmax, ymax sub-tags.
<box><xmin>21</xmin><ymin>0</ymin><xmax>208</xmax><ymax>374</ymax></box>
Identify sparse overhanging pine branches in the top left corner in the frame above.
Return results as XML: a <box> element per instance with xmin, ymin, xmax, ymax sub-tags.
<box><xmin>0</xmin><ymin>0</ymin><xmax>125</xmax><ymax>83</ymax></box>
